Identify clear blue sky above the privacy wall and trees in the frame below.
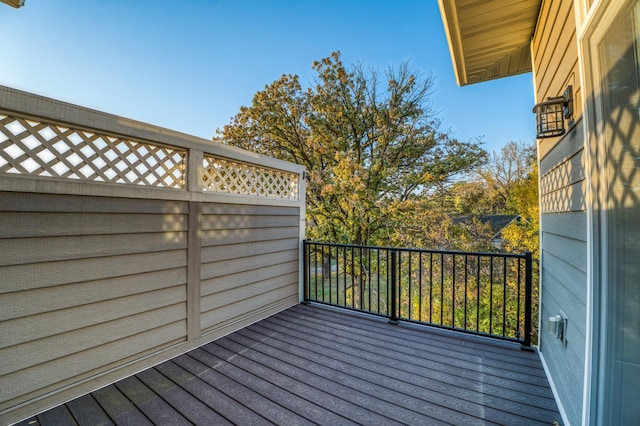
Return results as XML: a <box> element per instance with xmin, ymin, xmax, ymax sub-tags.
<box><xmin>0</xmin><ymin>0</ymin><xmax>535</xmax><ymax>150</ymax></box>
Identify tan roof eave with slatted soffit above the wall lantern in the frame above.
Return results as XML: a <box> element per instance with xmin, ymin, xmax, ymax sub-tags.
<box><xmin>438</xmin><ymin>0</ymin><xmax>542</xmax><ymax>86</ymax></box>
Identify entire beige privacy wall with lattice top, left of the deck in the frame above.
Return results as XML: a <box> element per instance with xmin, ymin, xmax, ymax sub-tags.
<box><xmin>0</xmin><ymin>86</ymin><xmax>304</xmax><ymax>424</ymax></box>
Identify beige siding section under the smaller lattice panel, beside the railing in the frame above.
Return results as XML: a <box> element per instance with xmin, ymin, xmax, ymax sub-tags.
<box><xmin>200</xmin><ymin>203</ymin><xmax>300</xmax><ymax>333</ymax></box>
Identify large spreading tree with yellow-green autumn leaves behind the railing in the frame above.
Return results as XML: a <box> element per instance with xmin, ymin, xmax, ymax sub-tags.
<box><xmin>214</xmin><ymin>52</ymin><xmax>486</xmax><ymax>245</ymax></box>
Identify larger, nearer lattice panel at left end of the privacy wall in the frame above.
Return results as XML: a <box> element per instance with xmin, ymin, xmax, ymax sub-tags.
<box><xmin>0</xmin><ymin>114</ymin><xmax>186</xmax><ymax>188</ymax></box>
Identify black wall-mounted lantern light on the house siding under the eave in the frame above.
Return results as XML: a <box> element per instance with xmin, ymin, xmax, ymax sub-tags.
<box><xmin>533</xmin><ymin>86</ymin><xmax>573</xmax><ymax>139</ymax></box>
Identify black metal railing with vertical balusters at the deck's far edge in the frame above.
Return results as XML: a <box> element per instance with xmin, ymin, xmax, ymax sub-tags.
<box><xmin>304</xmin><ymin>241</ymin><xmax>532</xmax><ymax>347</ymax></box>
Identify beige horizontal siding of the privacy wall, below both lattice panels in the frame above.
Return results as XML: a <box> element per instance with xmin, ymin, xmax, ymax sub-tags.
<box><xmin>0</xmin><ymin>192</ymin><xmax>300</xmax><ymax>426</ymax></box>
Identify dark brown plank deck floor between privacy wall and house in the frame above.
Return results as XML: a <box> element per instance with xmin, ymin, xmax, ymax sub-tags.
<box><xmin>20</xmin><ymin>305</ymin><xmax>561</xmax><ymax>425</ymax></box>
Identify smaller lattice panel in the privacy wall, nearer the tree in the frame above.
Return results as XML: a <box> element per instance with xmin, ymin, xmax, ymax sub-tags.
<box><xmin>203</xmin><ymin>156</ymin><xmax>298</xmax><ymax>200</ymax></box>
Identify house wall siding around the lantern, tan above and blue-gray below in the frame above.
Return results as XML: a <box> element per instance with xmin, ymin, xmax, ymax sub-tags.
<box><xmin>532</xmin><ymin>1</ymin><xmax>588</xmax><ymax>424</ymax></box>
